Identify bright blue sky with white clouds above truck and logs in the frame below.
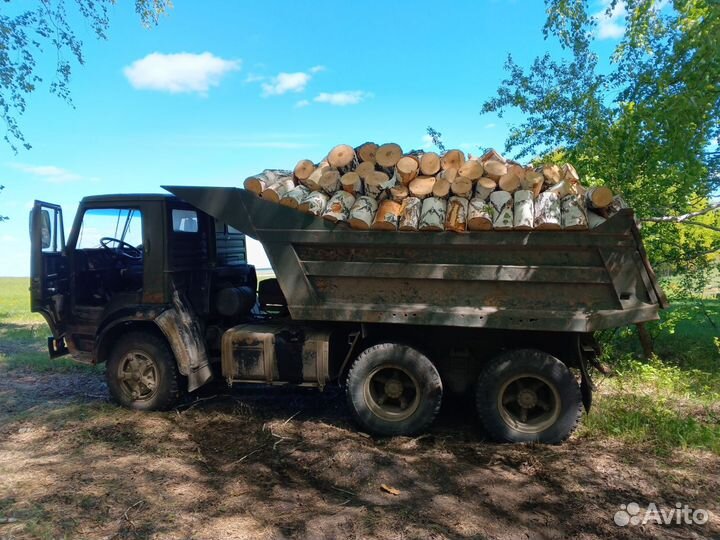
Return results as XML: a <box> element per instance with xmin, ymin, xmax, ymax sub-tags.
<box><xmin>0</xmin><ymin>0</ymin><xmax>622</xmax><ymax>276</ymax></box>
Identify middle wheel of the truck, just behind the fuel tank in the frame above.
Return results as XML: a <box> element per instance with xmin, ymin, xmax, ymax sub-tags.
<box><xmin>346</xmin><ymin>343</ymin><xmax>442</xmax><ymax>436</ymax></box>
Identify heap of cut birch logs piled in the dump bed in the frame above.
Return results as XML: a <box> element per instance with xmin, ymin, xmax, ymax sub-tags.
<box><xmin>244</xmin><ymin>142</ymin><xmax>625</xmax><ymax>232</ymax></box>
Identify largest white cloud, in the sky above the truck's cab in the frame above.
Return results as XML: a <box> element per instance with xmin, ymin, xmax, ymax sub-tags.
<box><xmin>123</xmin><ymin>52</ymin><xmax>241</xmax><ymax>94</ymax></box>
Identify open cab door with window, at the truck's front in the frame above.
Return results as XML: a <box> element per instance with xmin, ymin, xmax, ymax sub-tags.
<box><xmin>30</xmin><ymin>201</ymin><xmax>69</xmax><ymax>358</ymax></box>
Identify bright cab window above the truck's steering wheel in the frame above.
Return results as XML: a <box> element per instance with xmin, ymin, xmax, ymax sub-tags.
<box><xmin>77</xmin><ymin>208</ymin><xmax>142</xmax><ymax>249</ymax></box>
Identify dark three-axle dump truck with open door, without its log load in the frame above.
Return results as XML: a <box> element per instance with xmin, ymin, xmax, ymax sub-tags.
<box><xmin>30</xmin><ymin>186</ymin><xmax>667</xmax><ymax>443</ymax></box>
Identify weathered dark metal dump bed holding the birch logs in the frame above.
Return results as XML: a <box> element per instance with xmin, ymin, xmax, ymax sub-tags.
<box><xmin>166</xmin><ymin>186</ymin><xmax>667</xmax><ymax>332</ymax></box>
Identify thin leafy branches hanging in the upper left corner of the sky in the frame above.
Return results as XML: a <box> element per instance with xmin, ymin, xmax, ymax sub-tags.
<box><xmin>0</xmin><ymin>0</ymin><xmax>172</xmax><ymax>152</ymax></box>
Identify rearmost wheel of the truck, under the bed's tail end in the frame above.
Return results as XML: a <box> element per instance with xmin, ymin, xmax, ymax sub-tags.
<box><xmin>475</xmin><ymin>349</ymin><xmax>582</xmax><ymax>444</ymax></box>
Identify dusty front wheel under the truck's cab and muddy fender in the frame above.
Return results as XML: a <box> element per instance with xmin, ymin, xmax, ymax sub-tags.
<box><xmin>105</xmin><ymin>332</ymin><xmax>182</xmax><ymax>411</ymax></box>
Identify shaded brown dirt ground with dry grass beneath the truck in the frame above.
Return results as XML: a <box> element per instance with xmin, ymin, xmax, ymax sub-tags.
<box><xmin>0</xmin><ymin>369</ymin><xmax>720</xmax><ymax>540</ymax></box>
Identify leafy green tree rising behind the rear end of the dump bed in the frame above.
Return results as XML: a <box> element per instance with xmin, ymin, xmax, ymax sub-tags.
<box><xmin>482</xmin><ymin>0</ymin><xmax>720</xmax><ymax>296</ymax></box>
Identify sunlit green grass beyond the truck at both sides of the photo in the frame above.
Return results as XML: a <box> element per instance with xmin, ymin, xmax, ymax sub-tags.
<box><xmin>0</xmin><ymin>278</ymin><xmax>720</xmax><ymax>454</ymax></box>
